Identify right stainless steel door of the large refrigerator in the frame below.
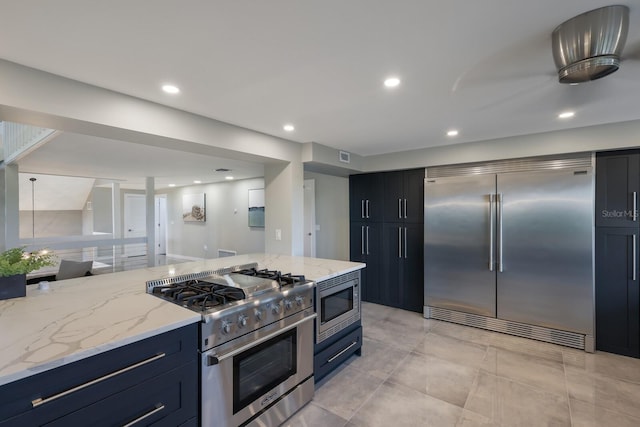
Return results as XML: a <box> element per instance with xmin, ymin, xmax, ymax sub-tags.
<box><xmin>497</xmin><ymin>168</ymin><xmax>594</xmax><ymax>335</ymax></box>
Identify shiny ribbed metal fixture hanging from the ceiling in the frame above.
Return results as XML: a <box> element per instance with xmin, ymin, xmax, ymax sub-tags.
<box><xmin>552</xmin><ymin>5</ymin><xmax>629</xmax><ymax>83</ymax></box>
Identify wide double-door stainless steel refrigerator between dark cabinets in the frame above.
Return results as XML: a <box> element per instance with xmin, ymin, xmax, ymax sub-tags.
<box><xmin>424</xmin><ymin>154</ymin><xmax>594</xmax><ymax>351</ymax></box>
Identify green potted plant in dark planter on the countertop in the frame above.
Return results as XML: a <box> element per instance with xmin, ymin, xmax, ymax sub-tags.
<box><xmin>0</xmin><ymin>247</ymin><xmax>55</xmax><ymax>300</ymax></box>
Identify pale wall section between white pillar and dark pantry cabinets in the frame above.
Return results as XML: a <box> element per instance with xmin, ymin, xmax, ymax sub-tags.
<box><xmin>304</xmin><ymin>172</ymin><xmax>349</xmax><ymax>261</ymax></box>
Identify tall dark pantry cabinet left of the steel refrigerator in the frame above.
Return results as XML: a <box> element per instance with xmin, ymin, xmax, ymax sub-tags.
<box><xmin>349</xmin><ymin>169</ymin><xmax>424</xmax><ymax>312</ymax></box>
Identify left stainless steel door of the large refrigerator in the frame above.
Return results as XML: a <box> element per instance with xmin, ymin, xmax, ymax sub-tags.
<box><xmin>424</xmin><ymin>175</ymin><xmax>496</xmax><ymax>317</ymax></box>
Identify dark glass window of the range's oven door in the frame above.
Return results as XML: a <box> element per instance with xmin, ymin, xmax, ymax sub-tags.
<box><xmin>233</xmin><ymin>328</ymin><xmax>298</xmax><ymax>414</ymax></box>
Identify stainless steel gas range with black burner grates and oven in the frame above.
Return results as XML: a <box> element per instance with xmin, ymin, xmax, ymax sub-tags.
<box><xmin>147</xmin><ymin>264</ymin><xmax>316</xmax><ymax>427</ymax></box>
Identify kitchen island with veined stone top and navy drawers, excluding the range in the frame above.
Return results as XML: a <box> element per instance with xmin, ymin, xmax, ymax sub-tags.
<box><xmin>0</xmin><ymin>254</ymin><xmax>364</xmax><ymax>427</ymax></box>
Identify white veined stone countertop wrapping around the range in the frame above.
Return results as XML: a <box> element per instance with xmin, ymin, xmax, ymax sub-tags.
<box><xmin>0</xmin><ymin>254</ymin><xmax>365</xmax><ymax>385</ymax></box>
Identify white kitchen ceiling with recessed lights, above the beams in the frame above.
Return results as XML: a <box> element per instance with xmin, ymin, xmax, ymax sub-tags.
<box><xmin>0</xmin><ymin>0</ymin><xmax>640</xmax><ymax>160</ymax></box>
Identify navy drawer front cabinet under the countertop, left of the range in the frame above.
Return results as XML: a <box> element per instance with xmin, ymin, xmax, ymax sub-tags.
<box><xmin>0</xmin><ymin>324</ymin><xmax>198</xmax><ymax>427</ymax></box>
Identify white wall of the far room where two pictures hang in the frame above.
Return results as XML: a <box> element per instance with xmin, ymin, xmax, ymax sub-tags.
<box><xmin>168</xmin><ymin>178</ymin><xmax>265</xmax><ymax>258</ymax></box>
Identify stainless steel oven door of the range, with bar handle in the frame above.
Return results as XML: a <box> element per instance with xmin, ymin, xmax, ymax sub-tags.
<box><xmin>200</xmin><ymin>310</ymin><xmax>316</xmax><ymax>427</ymax></box>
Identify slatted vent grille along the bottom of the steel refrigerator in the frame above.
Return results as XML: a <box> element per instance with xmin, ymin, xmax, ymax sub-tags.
<box><xmin>428</xmin><ymin>307</ymin><xmax>585</xmax><ymax>350</ymax></box>
